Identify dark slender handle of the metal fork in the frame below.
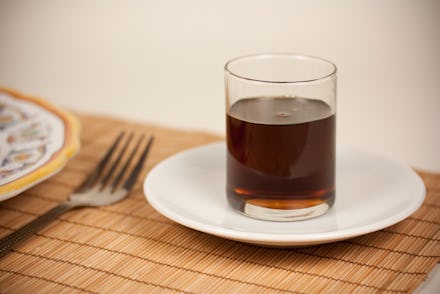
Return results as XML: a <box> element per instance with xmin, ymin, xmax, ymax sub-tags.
<box><xmin>0</xmin><ymin>202</ymin><xmax>76</xmax><ymax>258</ymax></box>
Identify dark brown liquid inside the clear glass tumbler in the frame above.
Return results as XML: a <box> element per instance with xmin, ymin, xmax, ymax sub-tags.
<box><xmin>226</xmin><ymin>97</ymin><xmax>336</xmax><ymax>210</ymax></box>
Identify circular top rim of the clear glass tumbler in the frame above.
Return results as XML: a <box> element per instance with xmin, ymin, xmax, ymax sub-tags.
<box><xmin>224</xmin><ymin>52</ymin><xmax>337</xmax><ymax>84</ymax></box>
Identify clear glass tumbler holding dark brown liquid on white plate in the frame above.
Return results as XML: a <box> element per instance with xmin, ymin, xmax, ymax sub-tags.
<box><xmin>225</xmin><ymin>53</ymin><xmax>336</xmax><ymax>221</ymax></box>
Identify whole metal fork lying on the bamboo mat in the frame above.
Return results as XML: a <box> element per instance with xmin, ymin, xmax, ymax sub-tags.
<box><xmin>0</xmin><ymin>132</ymin><xmax>154</xmax><ymax>257</ymax></box>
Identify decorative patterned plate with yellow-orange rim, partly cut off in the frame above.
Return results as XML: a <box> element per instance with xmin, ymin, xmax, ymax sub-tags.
<box><xmin>0</xmin><ymin>88</ymin><xmax>79</xmax><ymax>201</ymax></box>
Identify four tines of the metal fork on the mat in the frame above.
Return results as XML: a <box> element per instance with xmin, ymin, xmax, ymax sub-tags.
<box><xmin>77</xmin><ymin>131</ymin><xmax>154</xmax><ymax>192</ymax></box>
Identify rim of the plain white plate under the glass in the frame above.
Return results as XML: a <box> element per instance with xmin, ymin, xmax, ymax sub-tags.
<box><xmin>143</xmin><ymin>141</ymin><xmax>426</xmax><ymax>246</ymax></box>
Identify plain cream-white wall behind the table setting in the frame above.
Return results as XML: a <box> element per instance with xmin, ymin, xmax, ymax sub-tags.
<box><xmin>0</xmin><ymin>0</ymin><xmax>440</xmax><ymax>171</ymax></box>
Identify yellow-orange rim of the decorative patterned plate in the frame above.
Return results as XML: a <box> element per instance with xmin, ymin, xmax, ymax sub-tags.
<box><xmin>0</xmin><ymin>87</ymin><xmax>80</xmax><ymax>201</ymax></box>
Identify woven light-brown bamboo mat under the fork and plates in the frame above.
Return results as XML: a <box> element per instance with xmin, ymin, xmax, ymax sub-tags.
<box><xmin>0</xmin><ymin>115</ymin><xmax>440</xmax><ymax>293</ymax></box>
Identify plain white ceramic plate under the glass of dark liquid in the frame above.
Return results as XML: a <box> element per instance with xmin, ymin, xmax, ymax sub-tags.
<box><xmin>144</xmin><ymin>142</ymin><xmax>425</xmax><ymax>246</ymax></box>
